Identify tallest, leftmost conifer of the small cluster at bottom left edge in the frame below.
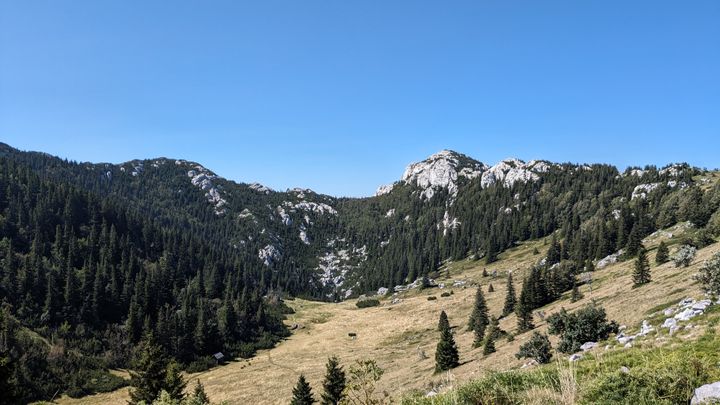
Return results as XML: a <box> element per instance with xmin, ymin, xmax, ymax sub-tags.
<box><xmin>130</xmin><ymin>333</ymin><xmax>167</xmax><ymax>404</ymax></box>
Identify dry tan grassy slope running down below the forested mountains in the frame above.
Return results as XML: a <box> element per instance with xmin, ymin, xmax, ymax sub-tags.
<box><xmin>60</xmin><ymin>223</ymin><xmax>720</xmax><ymax>404</ymax></box>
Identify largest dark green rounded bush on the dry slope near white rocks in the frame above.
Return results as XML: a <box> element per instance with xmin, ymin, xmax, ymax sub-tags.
<box><xmin>547</xmin><ymin>303</ymin><xmax>618</xmax><ymax>353</ymax></box>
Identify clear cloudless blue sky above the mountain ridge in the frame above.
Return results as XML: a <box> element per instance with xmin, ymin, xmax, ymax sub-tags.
<box><xmin>0</xmin><ymin>0</ymin><xmax>720</xmax><ymax>196</ymax></box>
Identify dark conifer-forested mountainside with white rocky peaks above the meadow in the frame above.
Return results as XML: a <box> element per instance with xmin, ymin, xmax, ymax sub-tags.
<box><xmin>0</xmin><ymin>141</ymin><xmax>720</xmax><ymax>401</ymax></box>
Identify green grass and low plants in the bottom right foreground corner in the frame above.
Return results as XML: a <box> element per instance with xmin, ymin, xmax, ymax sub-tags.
<box><xmin>402</xmin><ymin>328</ymin><xmax>720</xmax><ymax>405</ymax></box>
